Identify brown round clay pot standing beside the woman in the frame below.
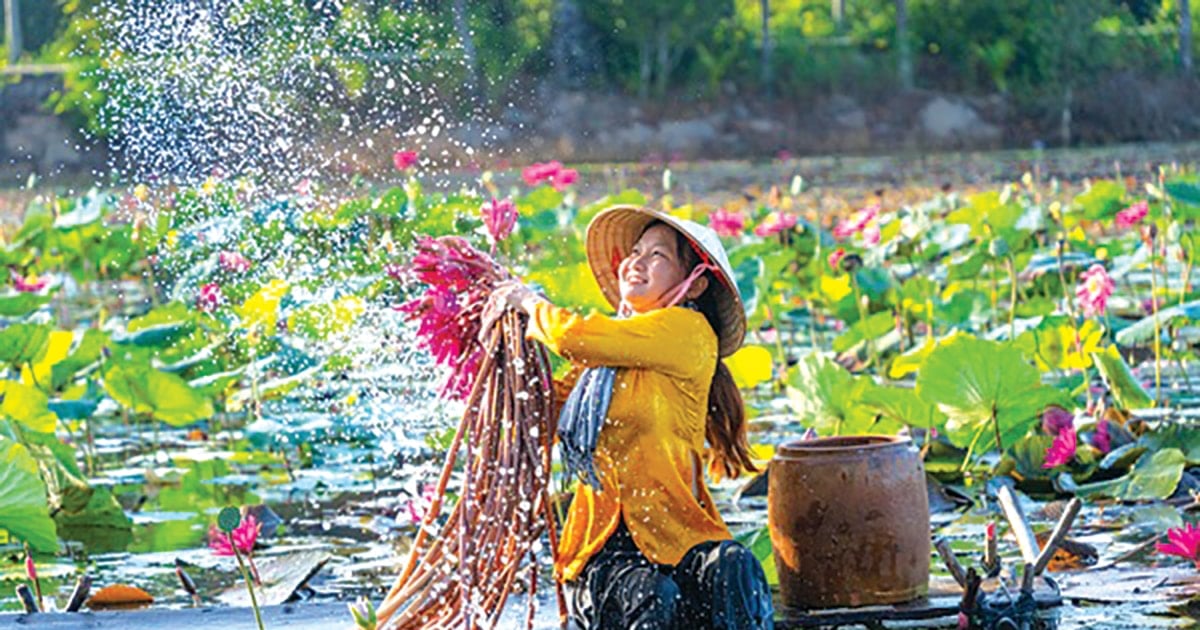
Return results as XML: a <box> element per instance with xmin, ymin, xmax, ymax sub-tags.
<box><xmin>767</xmin><ymin>436</ymin><xmax>930</xmax><ymax>608</ymax></box>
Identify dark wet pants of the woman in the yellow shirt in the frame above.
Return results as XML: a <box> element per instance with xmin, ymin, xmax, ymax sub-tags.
<box><xmin>565</xmin><ymin>522</ymin><xmax>774</xmax><ymax>630</ymax></box>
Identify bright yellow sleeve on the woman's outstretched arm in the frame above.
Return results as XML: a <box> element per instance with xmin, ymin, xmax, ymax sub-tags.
<box><xmin>526</xmin><ymin>301</ymin><xmax>716</xmax><ymax>378</ymax></box>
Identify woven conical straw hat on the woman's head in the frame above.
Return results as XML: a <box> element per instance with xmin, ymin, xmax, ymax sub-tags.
<box><xmin>587</xmin><ymin>205</ymin><xmax>746</xmax><ymax>356</ymax></box>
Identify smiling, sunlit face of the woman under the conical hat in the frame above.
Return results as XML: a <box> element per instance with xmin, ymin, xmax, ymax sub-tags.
<box><xmin>618</xmin><ymin>224</ymin><xmax>706</xmax><ymax>313</ymax></box>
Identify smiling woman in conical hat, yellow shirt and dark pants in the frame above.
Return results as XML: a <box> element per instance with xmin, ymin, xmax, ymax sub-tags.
<box><xmin>493</xmin><ymin>206</ymin><xmax>774</xmax><ymax>630</ymax></box>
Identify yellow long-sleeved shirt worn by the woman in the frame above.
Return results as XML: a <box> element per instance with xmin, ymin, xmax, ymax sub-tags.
<box><xmin>527</xmin><ymin>302</ymin><xmax>731</xmax><ymax>581</ymax></box>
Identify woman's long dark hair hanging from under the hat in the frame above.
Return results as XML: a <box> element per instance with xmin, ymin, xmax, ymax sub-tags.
<box><xmin>646</xmin><ymin>221</ymin><xmax>758</xmax><ymax>478</ymax></box>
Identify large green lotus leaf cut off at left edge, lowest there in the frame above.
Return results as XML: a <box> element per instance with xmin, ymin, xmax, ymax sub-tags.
<box><xmin>0</xmin><ymin>436</ymin><xmax>59</xmax><ymax>552</ymax></box>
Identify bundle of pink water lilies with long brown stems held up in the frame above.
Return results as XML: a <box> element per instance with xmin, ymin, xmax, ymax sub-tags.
<box><xmin>378</xmin><ymin>236</ymin><xmax>565</xmax><ymax>629</ymax></box>
